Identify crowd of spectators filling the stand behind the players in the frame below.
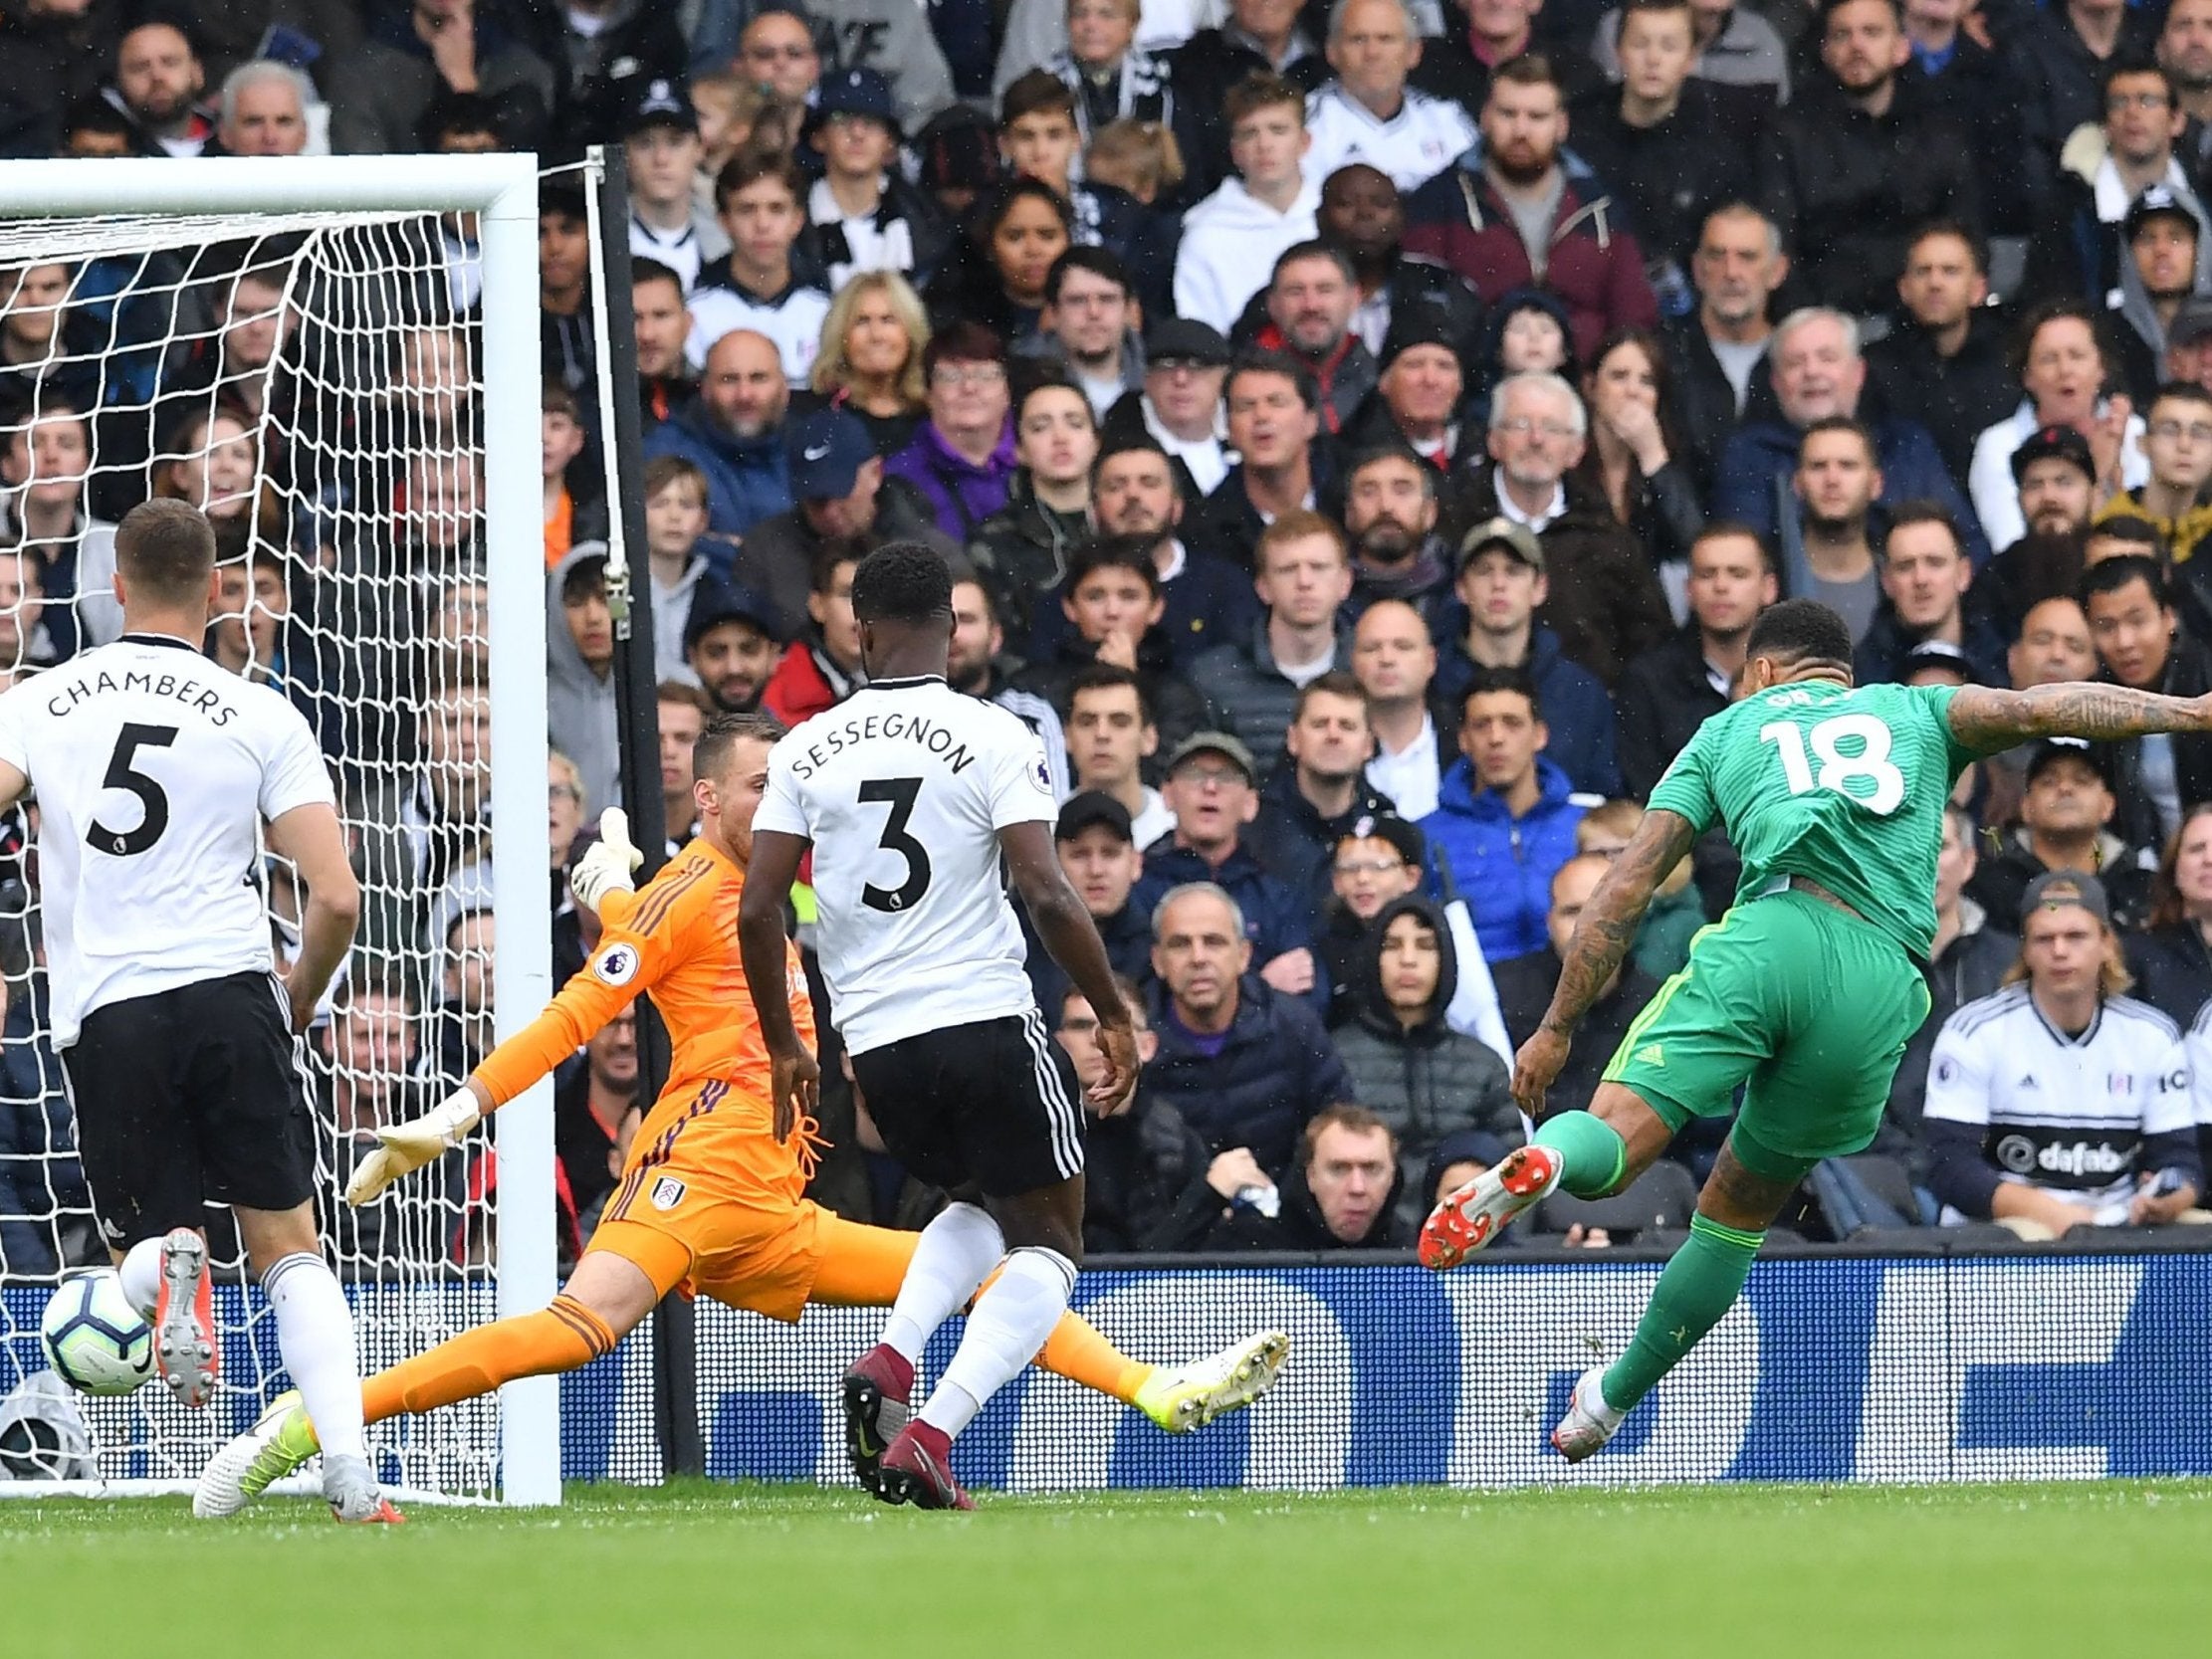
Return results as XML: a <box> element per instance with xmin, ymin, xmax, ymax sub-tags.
<box><xmin>13</xmin><ymin>0</ymin><xmax>2212</xmax><ymax>1272</ymax></box>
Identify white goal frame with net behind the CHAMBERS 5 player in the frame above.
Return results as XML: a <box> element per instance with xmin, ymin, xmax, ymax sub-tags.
<box><xmin>0</xmin><ymin>157</ymin><xmax>556</xmax><ymax>1502</ymax></box>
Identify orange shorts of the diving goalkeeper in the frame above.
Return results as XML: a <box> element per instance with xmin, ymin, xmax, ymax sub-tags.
<box><xmin>590</xmin><ymin>1084</ymin><xmax>825</xmax><ymax>1323</ymax></box>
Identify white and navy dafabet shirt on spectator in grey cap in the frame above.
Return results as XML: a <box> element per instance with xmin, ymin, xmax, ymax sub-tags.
<box><xmin>1926</xmin><ymin>984</ymin><xmax>2196</xmax><ymax>1221</ymax></box>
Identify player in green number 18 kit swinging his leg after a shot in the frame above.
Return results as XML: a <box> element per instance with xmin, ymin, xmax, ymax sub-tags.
<box><xmin>1421</xmin><ymin>599</ymin><xmax>2212</xmax><ymax>1462</ymax></box>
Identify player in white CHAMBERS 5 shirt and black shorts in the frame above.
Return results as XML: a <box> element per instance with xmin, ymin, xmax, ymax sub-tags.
<box><xmin>0</xmin><ymin>500</ymin><xmax>398</xmax><ymax>1522</ymax></box>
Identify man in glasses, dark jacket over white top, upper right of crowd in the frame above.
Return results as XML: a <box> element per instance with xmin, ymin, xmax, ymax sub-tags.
<box><xmin>2020</xmin><ymin>60</ymin><xmax>2194</xmax><ymax>306</ymax></box>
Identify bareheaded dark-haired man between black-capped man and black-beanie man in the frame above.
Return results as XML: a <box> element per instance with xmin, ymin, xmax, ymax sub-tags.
<box><xmin>1193</xmin><ymin>349</ymin><xmax>1343</xmax><ymax>570</ymax></box>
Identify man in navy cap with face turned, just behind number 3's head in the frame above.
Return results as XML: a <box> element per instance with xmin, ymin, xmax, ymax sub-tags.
<box><xmin>735</xmin><ymin>405</ymin><xmax>960</xmax><ymax>622</ymax></box>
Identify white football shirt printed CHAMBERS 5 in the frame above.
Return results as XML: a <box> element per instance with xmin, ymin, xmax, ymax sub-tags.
<box><xmin>0</xmin><ymin>635</ymin><xmax>336</xmax><ymax>1049</ymax></box>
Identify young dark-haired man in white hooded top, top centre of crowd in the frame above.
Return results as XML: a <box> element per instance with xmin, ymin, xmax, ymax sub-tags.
<box><xmin>1175</xmin><ymin>73</ymin><xmax>1321</xmax><ymax>334</ymax></box>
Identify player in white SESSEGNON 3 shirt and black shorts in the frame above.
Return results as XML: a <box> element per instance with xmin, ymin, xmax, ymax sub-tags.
<box><xmin>739</xmin><ymin>542</ymin><xmax>1137</xmax><ymax>1509</ymax></box>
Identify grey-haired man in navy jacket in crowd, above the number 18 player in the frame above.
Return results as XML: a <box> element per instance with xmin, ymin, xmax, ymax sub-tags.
<box><xmin>1712</xmin><ymin>310</ymin><xmax>1990</xmax><ymax>568</ymax></box>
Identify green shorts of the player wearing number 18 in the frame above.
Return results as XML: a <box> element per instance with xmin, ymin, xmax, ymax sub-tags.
<box><xmin>1606</xmin><ymin>892</ymin><xmax>1931</xmax><ymax>1161</ymax></box>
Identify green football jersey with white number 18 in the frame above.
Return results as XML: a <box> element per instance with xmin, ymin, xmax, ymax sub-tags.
<box><xmin>1651</xmin><ymin>679</ymin><xmax>1975</xmax><ymax>962</ymax></box>
